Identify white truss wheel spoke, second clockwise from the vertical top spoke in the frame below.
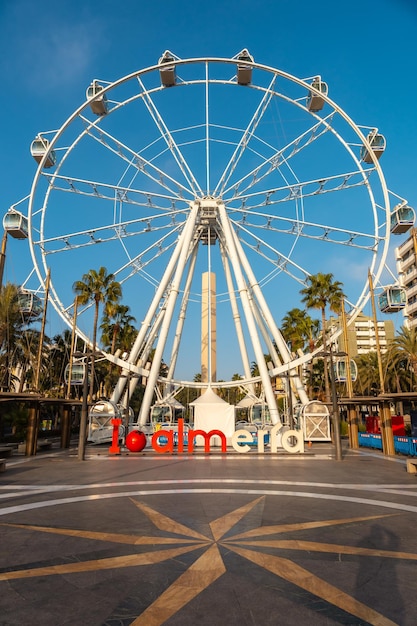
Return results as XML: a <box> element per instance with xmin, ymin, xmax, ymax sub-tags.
<box><xmin>224</xmin><ymin>113</ymin><xmax>334</xmax><ymax>195</ymax></box>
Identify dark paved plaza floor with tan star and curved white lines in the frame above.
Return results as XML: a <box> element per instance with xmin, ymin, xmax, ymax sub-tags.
<box><xmin>0</xmin><ymin>444</ymin><xmax>417</xmax><ymax>626</ymax></box>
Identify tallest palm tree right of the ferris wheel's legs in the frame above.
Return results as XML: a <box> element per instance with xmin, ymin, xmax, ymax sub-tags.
<box><xmin>301</xmin><ymin>272</ymin><xmax>345</xmax><ymax>402</ymax></box>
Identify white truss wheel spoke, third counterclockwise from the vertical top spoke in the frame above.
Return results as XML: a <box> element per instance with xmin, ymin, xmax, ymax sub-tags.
<box><xmin>43</xmin><ymin>172</ymin><xmax>185</xmax><ymax>211</ymax></box>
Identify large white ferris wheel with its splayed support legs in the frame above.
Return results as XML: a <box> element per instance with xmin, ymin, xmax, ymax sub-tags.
<box><xmin>22</xmin><ymin>50</ymin><xmax>392</xmax><ymax>423</ymax></box>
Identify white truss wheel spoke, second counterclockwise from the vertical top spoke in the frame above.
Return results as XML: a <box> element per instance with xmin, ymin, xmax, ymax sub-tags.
<box><xmin>80</xmin><ymin>115</ymin><xmax>194</xmax><ymax>198</ymax></box>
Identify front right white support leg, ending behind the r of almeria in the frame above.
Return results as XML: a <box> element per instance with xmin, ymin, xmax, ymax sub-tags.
<box><xmin>219</xmin><ymin>204</ymin><xmax>281</xmax><ymax>424</ymax></box>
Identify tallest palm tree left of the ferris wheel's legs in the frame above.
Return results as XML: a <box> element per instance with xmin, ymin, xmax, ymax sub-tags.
<box><xmin>73</xmin><ymin>267</ymin><xmax>122</xmax><ymax>398</ymax></box>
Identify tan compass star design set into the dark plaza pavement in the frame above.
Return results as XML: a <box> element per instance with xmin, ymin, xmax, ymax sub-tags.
<box><xmin>0</xmin><ymin>496</ymin><xmax>417</xmax><ymax>626</ymax></box>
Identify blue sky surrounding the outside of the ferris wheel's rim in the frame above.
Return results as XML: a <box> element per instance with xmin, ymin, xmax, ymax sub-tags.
<box><xmin>0</xmin><ymin>0</ymin><xmax>417</xmax><ymax>378</ymax></box>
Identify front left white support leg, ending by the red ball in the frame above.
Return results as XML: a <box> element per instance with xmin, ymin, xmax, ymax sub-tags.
<box><xmin>138</xmin><ymin>204</ymin><xmax>198</xmax><ymax>426</ymax></box>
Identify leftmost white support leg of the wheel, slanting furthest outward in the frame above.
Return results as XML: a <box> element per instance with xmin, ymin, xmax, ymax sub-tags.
<box><xmin>111</xmin><ymin>205</ymin><xmax>196</xmax><ymax>403</ymax></box>
